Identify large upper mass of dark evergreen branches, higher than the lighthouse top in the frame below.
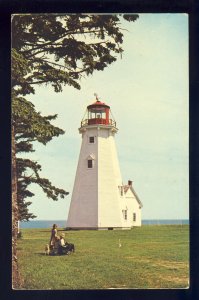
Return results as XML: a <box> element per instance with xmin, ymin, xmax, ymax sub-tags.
<box><xmin>12</xmin><ymin>14</ymin><xmax>138</xmax><ymax>95</ymax></box>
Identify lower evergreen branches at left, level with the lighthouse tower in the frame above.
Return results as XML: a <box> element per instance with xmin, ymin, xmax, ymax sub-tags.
<box><xmin>12</xmin><ymin>96</ymin><xmax>68</xmax><ymax>221</ymax></box>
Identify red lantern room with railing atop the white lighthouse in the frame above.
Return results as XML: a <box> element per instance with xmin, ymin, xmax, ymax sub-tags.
<box><xmin>81</xmin><ymin>96</ymin><xmax>116</xmax><ymax>127</ymax></box>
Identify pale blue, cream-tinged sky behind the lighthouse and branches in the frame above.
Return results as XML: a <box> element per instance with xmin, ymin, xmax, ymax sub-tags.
<box><xmin>22</xmin><ymin>14</ymin><xmax>189</xmax><ymax>220</ymax></box>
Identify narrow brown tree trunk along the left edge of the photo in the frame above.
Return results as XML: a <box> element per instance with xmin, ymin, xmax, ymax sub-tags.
<box><xmin>12</xmin><ymin>125</ymin><xmax>21</xmax><ymax>289</ymax></box>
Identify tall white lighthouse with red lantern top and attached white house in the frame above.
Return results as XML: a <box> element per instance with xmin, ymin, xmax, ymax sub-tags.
<box><xmin>67</xmin><ymin>96</ymin><xmax>142</xmax><ymax>229</ymax></box>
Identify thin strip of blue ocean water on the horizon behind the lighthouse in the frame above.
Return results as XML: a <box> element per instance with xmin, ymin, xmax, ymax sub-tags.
<box><xmin>20</xmin><ymin>219</ymin><xmax>189</xmax><ymax>228</ymax></box>
